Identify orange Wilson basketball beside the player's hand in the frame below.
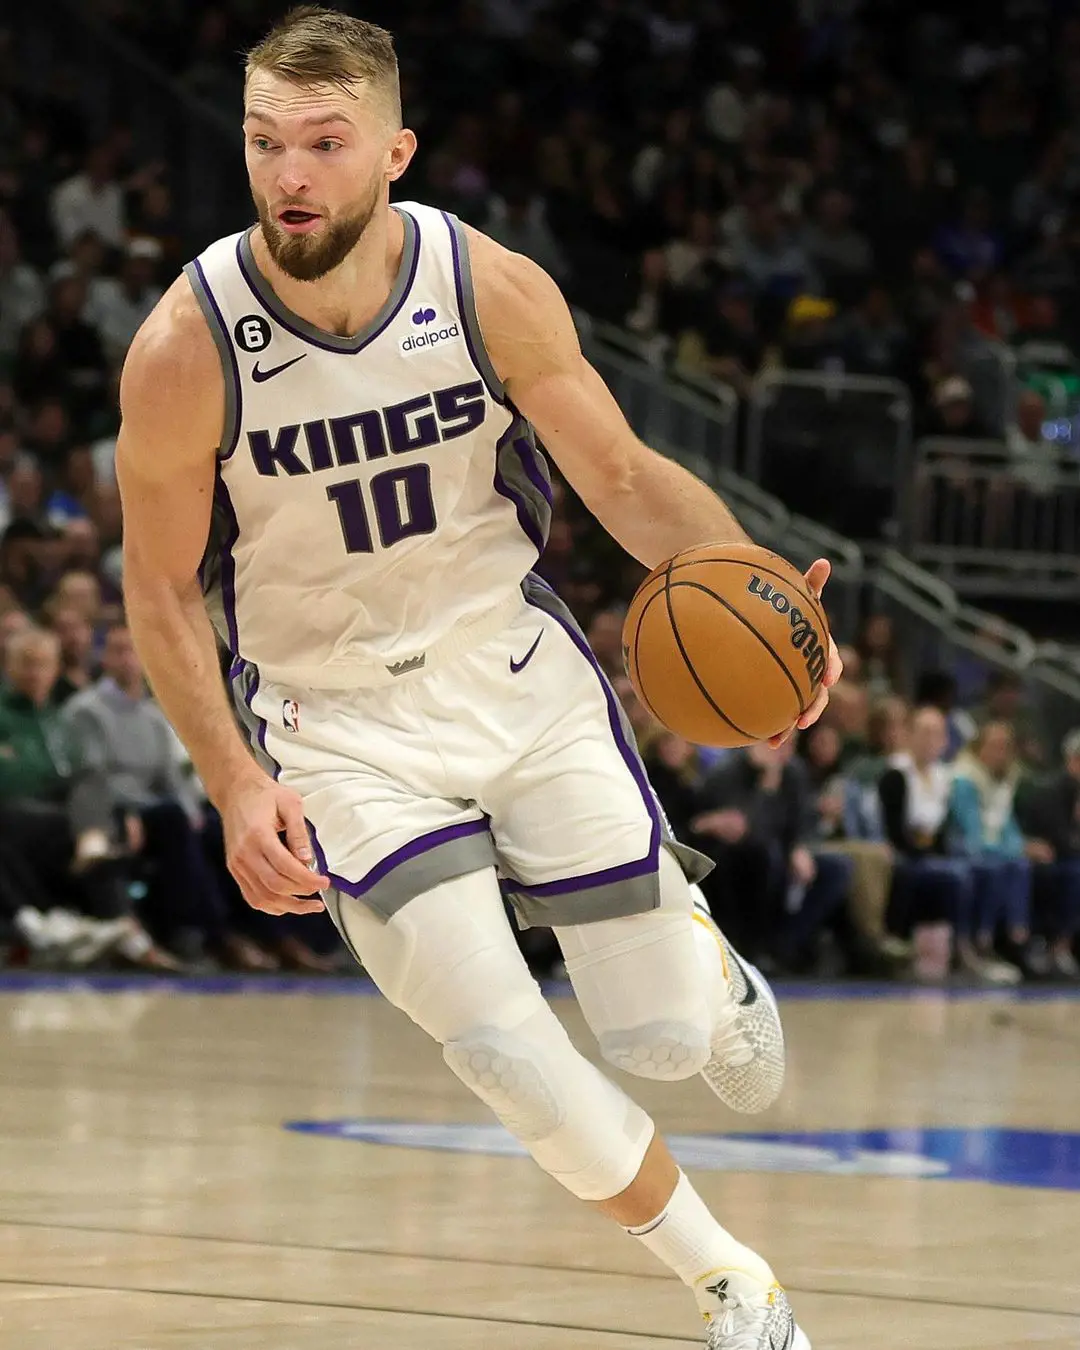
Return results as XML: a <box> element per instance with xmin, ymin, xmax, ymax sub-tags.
<box><xmin>622</xmin><ymin>544</ymin><xmax>829</xmax><ymax>745</ymax></box>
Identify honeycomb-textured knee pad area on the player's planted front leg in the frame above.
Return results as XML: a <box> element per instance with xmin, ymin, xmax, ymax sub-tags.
<box><xmin>443</xmin><ymin>1026</ymin><xmax>564</xmax><ymax>1143</ymax></box>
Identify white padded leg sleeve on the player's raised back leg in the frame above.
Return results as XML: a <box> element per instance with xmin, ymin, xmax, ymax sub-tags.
<box><xmin>555</xmin><ymin>851</ymin><xmax>730</xmax><ymax>1080</ymax></box>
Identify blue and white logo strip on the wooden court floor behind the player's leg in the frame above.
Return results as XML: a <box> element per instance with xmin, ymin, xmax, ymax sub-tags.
<box><xmin>285</xmin><ymin>1121</ymin><xmax>1080</xmax><ymax>1191</ymax></box>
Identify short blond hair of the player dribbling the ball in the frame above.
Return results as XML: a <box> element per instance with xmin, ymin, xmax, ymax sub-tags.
<box><xmin>244</xmin><ymin>4</ymin><xmax>401</xmax><ymax>127</ymax></box>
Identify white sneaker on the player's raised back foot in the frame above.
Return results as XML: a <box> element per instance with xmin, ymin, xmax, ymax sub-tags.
<box><xmin>694</xmin><ymin>903</ymin><xmax>784</xmax><ymax>1112</ymax></box>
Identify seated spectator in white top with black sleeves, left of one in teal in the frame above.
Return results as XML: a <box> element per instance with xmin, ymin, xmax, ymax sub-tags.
<box><xmin>878</xmin><ymin>706</ymin><xmax>972</xmax><ymax>981</ymax></box>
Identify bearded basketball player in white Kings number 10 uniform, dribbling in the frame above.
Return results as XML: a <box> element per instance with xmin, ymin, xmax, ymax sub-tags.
<box><xmin>117</xmin><ymin>7</ymin><xmax>840</xmax><ymax>1350</ymax></box>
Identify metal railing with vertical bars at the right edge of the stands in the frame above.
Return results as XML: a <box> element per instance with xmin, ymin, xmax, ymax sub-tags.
<box><xmin>902</xmin><ymin>437</ymin><xmax>1080</xmax><ymax>598</ymax></box>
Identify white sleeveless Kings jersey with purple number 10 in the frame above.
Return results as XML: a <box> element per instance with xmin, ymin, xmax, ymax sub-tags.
<box><xmin>185</xmin><ymin>203</ymin><xmax>551</xmax><ymax>689</ymax></box>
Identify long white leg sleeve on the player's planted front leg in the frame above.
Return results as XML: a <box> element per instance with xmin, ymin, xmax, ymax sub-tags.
<box><xmin>340</xmin><ymin>869</ymin><xmax>653</xmax><ymax>1200</ymax></box>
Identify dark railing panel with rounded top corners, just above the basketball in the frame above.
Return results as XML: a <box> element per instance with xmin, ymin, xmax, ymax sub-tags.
<box><xmin>745</xmin><ymin>370</ymin><xmax>913</xmax><ymax>540</ymax></box>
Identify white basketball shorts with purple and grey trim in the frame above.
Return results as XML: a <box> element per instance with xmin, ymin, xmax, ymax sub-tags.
<box><xmin>234</xmin><ymin>576</ymin><xmax>711</xmax><ymax>926</ymax></box>
